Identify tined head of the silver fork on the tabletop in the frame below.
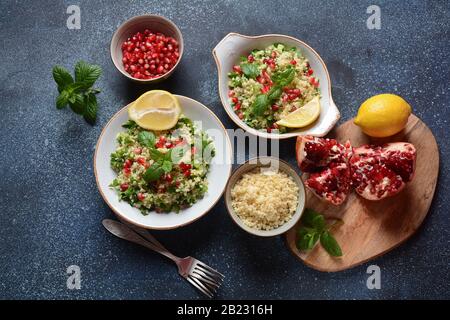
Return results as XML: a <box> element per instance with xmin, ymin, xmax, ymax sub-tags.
<box><xmin>186</xmin><ymin>260</ymin><xmax>224</xmax><ymax>298</ymax></box>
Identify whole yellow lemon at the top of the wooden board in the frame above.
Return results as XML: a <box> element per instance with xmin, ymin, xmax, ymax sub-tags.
<box><xmin>354</xmin><ymin>93</ymin><xmax>411</xmax><ymax>138</ymax></box>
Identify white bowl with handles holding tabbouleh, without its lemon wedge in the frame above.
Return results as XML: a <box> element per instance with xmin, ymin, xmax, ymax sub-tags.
<box><xmin>213</xmin><ymin>33</ymin><xmax>340</xmax><ymax>139</ymax></box>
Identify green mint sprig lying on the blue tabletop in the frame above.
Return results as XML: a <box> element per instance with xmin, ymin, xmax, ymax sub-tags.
<box><xmin>53</xmin><ymin>61</ymin><xmax>102</xmax><ymax>124</ymax></box>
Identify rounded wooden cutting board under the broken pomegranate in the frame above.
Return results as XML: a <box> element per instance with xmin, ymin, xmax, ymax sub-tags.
<box><xmin>286</xmin><ymin>115</ymin><xmax>439</xmax><ymax>272</ymax></box>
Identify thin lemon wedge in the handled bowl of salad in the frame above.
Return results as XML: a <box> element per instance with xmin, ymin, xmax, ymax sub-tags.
<box><xmin>277</xmin><ymin>97</ymin><xmax>320</xmax><ymax>128</ymax></box>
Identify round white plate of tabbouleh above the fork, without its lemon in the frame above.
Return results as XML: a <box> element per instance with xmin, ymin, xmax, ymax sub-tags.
<box><xmin>94</xmin><ymin>96</ymin><xmax>232</xmax><ymax>229</ymax></box>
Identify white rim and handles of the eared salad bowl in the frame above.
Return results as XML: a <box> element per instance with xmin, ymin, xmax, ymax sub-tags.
<box><xmin>212</xmin><ymin>32</ymin><xmax>340</xmax><ymax>139</ymax></box>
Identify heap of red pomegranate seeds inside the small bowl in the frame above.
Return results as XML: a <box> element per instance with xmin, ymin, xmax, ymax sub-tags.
<box><xmin>121</xmin><ymin>29</ymin><xmax>180</xmax><ymax>79</ymax></box>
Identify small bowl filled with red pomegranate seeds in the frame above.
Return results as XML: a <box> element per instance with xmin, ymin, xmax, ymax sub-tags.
<box><xmin>111</xmin><ymin>14</ymin><xmax>183</xmax><ymax>83</ymax></box>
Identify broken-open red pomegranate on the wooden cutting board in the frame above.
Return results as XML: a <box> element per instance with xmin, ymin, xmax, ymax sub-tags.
<box><xmin>296</xmin><ymin>136</ymin><xmax>416</xmax><ymax>205</ymax></box>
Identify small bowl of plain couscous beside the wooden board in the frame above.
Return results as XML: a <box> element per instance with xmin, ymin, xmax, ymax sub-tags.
<box><xmin>225</xmin><ymin>157</ymin><xmax>306</xmax><ymax>237</ymax></box>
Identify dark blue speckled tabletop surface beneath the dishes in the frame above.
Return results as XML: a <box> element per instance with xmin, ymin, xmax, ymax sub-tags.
<box><xmin>0</xmin><ymin>0</ymin><xmax>450</xmax><ymax>299</ymax></box>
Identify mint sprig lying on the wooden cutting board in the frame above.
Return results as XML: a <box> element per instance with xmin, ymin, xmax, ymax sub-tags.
<box><xmin>297</xmin><ymin>209</ymin><xmax>342</xmax><ymax>257</ymax></box>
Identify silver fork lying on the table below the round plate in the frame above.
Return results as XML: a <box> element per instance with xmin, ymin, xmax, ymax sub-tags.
<box><xmin>102</xmin><ymin>219</ymin><xmax>224</xmax><ymax>298</ymax></box>
